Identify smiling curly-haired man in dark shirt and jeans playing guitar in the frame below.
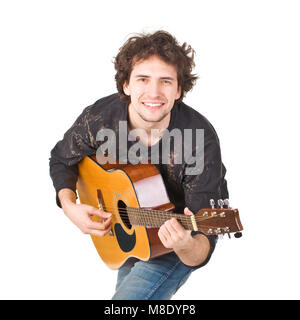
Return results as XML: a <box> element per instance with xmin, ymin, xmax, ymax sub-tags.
<box><xmin>50</xmin><ymin>31</ymin><xmax>228</xmax><ymax>299</ymax></box>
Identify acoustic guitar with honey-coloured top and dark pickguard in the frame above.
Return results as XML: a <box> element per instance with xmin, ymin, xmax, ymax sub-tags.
<box><xmin>77</xmin><ymin>156</ymin><xmax>243</xmax><ymax>269</ymax></box>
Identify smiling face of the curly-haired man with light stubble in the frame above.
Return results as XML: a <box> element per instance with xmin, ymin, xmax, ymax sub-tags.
<box><xmin>123</xmin><ymin>56</ymin><xmax>181</xmax><ymax>129</ymax></box>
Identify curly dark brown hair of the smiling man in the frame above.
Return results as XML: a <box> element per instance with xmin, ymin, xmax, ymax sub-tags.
<box><xmin>114</xmin><ymin>30</ymin><xmax>198</xmax><ymax>102</ymax></box>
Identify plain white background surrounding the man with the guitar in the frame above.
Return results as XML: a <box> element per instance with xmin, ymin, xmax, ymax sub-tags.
<box><xmin>0</xmin><ymin>0</ymin><xmax>300</xmax><ymax>299</ymax></box>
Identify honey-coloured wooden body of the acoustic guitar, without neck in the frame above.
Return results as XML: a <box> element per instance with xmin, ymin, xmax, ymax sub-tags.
<box><xmin>77</xmin><ymin>156</ymin><xmax>174</xmax><ymax>269</ymax></box>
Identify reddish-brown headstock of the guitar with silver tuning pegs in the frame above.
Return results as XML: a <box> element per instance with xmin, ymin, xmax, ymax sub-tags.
<box><xmin>195</xmin><ymin>199</ymin><xmax>243</xmax><ymax>238</ymax></box>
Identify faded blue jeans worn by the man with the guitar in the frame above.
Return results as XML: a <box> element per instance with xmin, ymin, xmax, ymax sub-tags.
<box><xmin>112</xmin><ymin>252</ymin><xmax>194</xmax><ymax>300</ymax></box>
